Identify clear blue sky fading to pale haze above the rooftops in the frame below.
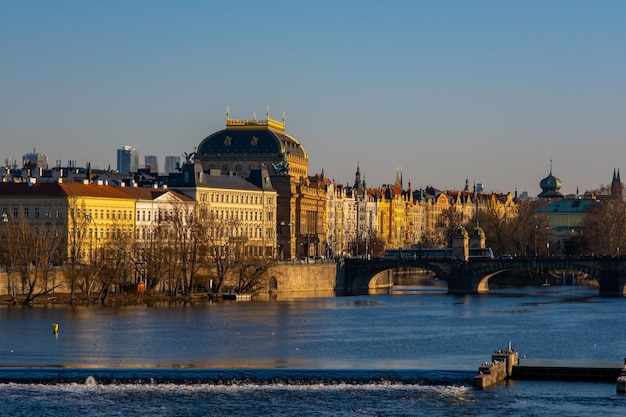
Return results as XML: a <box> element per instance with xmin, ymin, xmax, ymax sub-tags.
<box><xmin>0</xmin><ymin>0</ymin><xmax>626</xmax><ymax>196</ymax></box>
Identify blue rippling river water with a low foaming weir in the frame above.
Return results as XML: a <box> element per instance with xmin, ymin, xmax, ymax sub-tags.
<box><xmin>0</xmin><ymin>286</ymin><xmax>626</xmax><ymax>417</ymax></box>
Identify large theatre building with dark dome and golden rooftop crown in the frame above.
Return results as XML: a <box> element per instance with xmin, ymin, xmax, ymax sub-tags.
<box><xmin>193</xmin><ymin>110</ymin><xmax>327</xmax><ymax>259</ymax></box>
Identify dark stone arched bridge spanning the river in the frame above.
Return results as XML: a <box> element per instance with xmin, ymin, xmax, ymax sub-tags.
<box><xmin>343</xmin><ymin>257</ymin><xmax>626</xmax><ymax>297</ymax></box>
